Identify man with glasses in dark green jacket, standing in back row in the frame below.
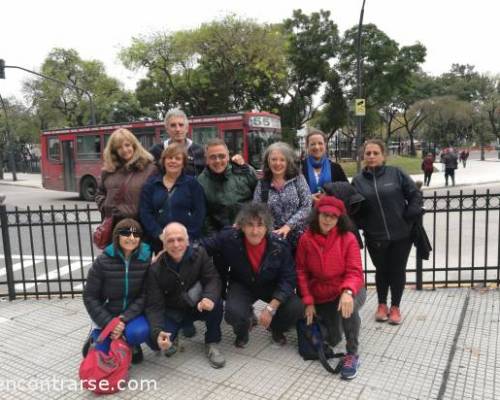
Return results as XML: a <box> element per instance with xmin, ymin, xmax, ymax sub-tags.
<box><xmin>198</xmin><ymin>139</ymin><xmax>257</xmax><ymax>233</ymax></box>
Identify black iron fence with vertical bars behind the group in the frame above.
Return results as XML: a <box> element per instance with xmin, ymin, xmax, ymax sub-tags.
<box><xmin>0</xmin><ymin>191</ymin><xmax>500</xmax><ymax>299</ymax></box>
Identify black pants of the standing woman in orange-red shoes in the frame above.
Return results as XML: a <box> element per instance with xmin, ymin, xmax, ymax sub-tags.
<box><xmin>366</xmin><ymin>238</ymin><xmax>412</xmax><ymax>307</ymax></box>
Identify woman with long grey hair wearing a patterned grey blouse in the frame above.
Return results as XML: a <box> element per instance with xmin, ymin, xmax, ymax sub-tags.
<box><xmin>254</xmin><ymin>142</ymin><xmax>312</xmax><ymax>249</ymax></box>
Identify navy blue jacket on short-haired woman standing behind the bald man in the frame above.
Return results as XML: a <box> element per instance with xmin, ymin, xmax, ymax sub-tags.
<box><xmin>139</xmin><ymin>174</ymin><xmax>206</xmax><ymax>250</ymax></box>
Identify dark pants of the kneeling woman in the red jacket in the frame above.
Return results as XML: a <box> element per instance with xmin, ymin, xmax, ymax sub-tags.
<box><xmin>315</xmin><ymin>288</ymin><xmax>366</xmax><ymax>354</ymax></box>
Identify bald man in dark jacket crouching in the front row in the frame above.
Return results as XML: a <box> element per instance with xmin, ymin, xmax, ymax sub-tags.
<box><xmin>145</xmin><ymin>222</ymin><xmax>226</xmax><ymax>368</ymax></box>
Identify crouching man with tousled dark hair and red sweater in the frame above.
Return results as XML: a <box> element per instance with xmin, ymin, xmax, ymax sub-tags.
<box><xmin>201</xmin><ymin>203</ymin><xmax>304</xmax><ymax>347</ymax></box>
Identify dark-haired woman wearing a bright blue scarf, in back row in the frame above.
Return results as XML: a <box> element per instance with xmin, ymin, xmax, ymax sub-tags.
<box><xmin>302</xmin><ymin>129</ymin><xmax>348</xmax><ymax>201</ymax></box>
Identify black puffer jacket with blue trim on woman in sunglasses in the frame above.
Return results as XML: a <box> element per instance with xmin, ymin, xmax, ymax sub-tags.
<box><xmin>83</xmin><ymin>243</ymin><xmax>151</xmax><ymax>328</ymax></box>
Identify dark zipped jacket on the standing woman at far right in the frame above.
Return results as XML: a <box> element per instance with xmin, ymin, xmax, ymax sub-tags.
<box><xmin>352</xmin><ymin>165</ymin><xmax>422</xmax><ymax>241</ymax></box>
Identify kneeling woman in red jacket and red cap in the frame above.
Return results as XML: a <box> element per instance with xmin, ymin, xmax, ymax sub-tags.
<box><xmin>296</xmin><ymin>196</ymin><xmax>366</xmax><ymax>379</ymax></box>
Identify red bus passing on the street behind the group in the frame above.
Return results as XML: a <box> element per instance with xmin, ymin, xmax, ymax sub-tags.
<box><xmin>40</xmin><ymin>112</ymin><xmax>281</xmax><ymax>201</ymax></box>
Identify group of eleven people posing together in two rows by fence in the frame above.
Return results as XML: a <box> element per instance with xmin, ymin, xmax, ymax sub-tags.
<box><xmin>83</xmin><ymin>109</ymin><xmax>421</xmax><ymax>379</ymax></box>
